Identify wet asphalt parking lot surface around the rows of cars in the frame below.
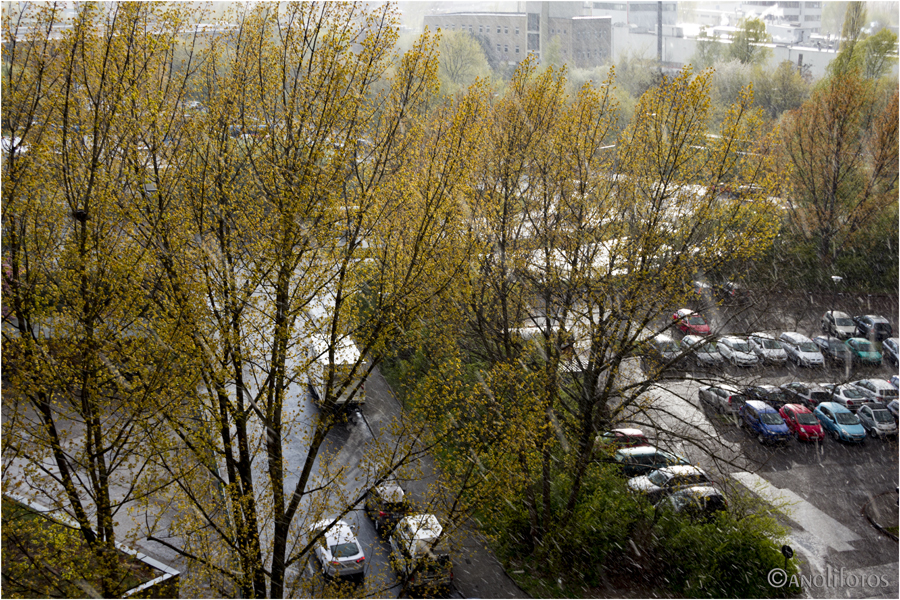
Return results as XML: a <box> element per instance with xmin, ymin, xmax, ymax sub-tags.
<box><xmin>644</xmin><ymin>290</ymin><xmax>900</xmax><ymax>598</ymax></box>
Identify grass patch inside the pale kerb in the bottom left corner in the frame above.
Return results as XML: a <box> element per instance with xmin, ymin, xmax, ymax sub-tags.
<box><xmin>0</xmin><ymin>497</ymin><xmax>162</xmax><ymax>598</ymax></box>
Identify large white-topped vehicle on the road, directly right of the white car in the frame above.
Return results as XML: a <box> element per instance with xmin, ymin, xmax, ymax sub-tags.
<box><xmin>390</xmin><ymin>514</ymin><xmax>453</xmax><ymax>592</ymax></box>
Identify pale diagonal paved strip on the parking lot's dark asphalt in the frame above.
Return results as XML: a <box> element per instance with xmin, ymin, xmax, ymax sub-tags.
<box><xmin>731</xmin><ymin>472</ymin><xmax>862</xmax><ymax>552</ymax></box>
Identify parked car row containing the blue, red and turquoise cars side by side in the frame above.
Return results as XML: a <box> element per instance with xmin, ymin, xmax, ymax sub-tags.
<box><xmin>699</xmin><ymin>376</ymin><xmax>900</xmax><ymax>443</ymax></box>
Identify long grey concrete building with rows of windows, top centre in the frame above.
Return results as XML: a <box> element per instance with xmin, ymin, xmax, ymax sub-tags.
<box><xmin>424</xmin><ymin>2</ymin><xmax>612</xmax><ymax>68</ymax></box>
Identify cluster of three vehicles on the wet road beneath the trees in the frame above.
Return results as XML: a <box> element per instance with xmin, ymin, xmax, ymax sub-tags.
<box><xmin>310</xmin><ymin>480</ymin><xmax>453</xmax><ymax>592</ymax></box>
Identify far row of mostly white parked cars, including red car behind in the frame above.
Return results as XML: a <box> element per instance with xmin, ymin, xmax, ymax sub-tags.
<box><xmin>651</xmin><ymin>308</ymin><xmax>900</xmax><ymax>367</ymax></box>
